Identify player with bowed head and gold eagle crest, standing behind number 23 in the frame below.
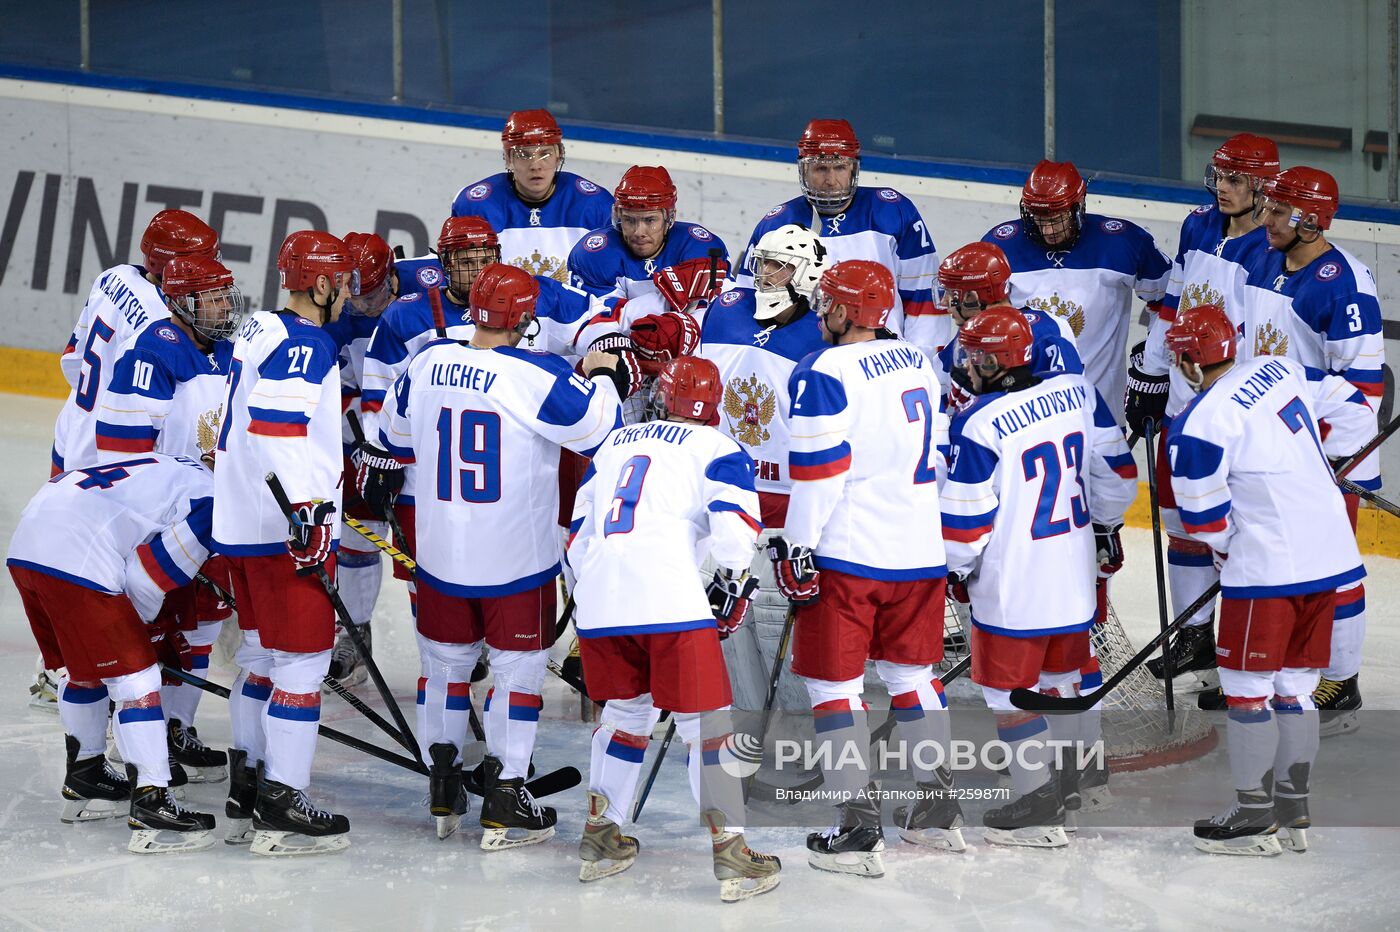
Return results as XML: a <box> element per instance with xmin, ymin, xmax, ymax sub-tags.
<box><xmin>981</xmin><ymin>161</ymin><xmax>1172</xmax><ymax>424</ymax></box>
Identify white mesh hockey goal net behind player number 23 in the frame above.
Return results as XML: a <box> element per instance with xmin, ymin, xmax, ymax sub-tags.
<box><xmin>941</xmin><ymin>599</ymin><xmax>1217</xmax><ymax>774</ymax></box>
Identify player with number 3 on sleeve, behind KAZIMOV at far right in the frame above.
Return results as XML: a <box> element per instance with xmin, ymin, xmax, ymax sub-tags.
<box><xmin>1240</xmin><ymin>165</ymin><xmax>1385</xmax><ymax>736</ymax></box>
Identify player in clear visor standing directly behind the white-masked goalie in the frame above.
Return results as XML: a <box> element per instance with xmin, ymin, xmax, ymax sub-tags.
<box><xmin>735</xmin><ymin>119</ymin><xmax>952</xmax><ymax>357</ymax></box>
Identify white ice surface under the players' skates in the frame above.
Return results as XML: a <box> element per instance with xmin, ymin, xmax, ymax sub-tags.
<box><xmin>0</xmin><ymin>396</ymin><xmax>1400</xmax><ymax>932</ymax></box>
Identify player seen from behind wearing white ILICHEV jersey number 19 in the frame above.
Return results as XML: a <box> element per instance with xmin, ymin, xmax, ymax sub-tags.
<box><xmin>364</xmin><ymin>263</ymin><xmax>626</xmax><ymax>851</ymax></box>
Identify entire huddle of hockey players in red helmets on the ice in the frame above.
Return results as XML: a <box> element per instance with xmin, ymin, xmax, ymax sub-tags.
<box><xmin>8</xmin><ymin>111</ymin><xmax>1382</xmax><ymax>900</ymax></box>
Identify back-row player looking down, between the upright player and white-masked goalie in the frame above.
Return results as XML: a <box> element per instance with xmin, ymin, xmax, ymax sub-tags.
<box><xmin>568</xmin><ymin>165</ymin><xmax>729</xmax><ymax>298</ymax></box>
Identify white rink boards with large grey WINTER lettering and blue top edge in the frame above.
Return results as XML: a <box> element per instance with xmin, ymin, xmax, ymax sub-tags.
<box><xmin>0</xmin><ymin>78</ymin><xmax>1400</xmax><ymax>487</ymax></box>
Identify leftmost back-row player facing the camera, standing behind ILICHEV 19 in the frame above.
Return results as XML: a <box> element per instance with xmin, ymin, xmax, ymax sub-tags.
<box><xmin>452</xmin><ymin>111</ymin><xmax>613</xmax><ymax>283</ymax></box>
